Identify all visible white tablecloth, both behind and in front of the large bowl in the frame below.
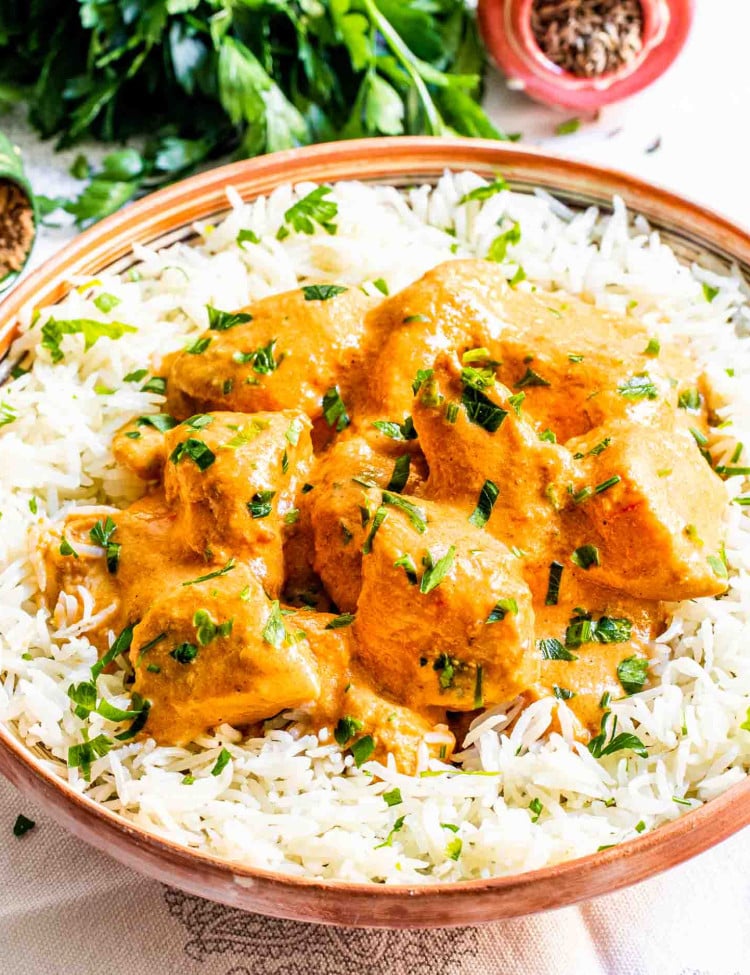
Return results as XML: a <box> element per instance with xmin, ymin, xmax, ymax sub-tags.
<box><xmin>0</xmin><ymin>0</ymin><xmax>750</xmax><ymax>975</ymax></box>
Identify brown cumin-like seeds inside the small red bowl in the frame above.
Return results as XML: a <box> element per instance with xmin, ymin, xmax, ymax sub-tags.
<box><xmin>531</xmin><ymin>0</ymin><xmax>643</xmax><ymax>78</ymax></box>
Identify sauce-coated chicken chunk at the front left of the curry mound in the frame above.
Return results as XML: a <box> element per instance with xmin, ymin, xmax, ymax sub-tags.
<box><xmin>130</xmin><ymin>565</ymin><xmax>320</xmax><ymax>744</ymax></box>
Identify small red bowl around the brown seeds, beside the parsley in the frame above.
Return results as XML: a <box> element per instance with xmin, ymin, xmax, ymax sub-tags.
<box><xmin>478</xmin><ymin>0</ymin><xmax>694</xmax><ymax>112</ymax></box>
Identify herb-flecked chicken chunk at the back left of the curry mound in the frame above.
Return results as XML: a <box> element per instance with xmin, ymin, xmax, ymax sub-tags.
<box><xmin>167</xmin><ymin>285</ymin><xmax>373</xmax><ymax>420</ymax></box>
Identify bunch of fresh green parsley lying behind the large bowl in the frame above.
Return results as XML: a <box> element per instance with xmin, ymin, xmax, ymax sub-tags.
<box><xmin>0</xmin><ymin>0</ymin><xmax>504</xmax><ymax>224</ymax></box>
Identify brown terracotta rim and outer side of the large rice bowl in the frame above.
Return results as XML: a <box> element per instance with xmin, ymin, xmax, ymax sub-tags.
<box><xmin>0</xmin><ymin>137</ymin><xmax>750</xmax><ymax>928</ymax></box>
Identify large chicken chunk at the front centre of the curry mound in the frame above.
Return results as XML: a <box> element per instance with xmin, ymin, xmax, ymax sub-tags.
<box><xmin>354</xmin><ymin>496</ymin><xmax>539</xmax><ymax>711</ymax></box>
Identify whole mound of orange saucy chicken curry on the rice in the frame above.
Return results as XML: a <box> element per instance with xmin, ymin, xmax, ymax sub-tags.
<box><xmin>39</xmin><ymin>260</ymin><xmax>727</xmax><ymax>772</ymax></box>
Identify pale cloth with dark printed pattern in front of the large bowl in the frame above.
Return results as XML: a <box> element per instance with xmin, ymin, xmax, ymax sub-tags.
<box><xmin>0</xmin><ymin>779</ymin><xmax>750</xmax><ymax>975</ymax></box>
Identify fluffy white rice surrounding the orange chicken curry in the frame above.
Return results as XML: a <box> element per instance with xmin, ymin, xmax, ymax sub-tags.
<box><xmin>0</xmin><ymin>173</ymin><xmax>750</xmax><ymax>884</ymax></box>
